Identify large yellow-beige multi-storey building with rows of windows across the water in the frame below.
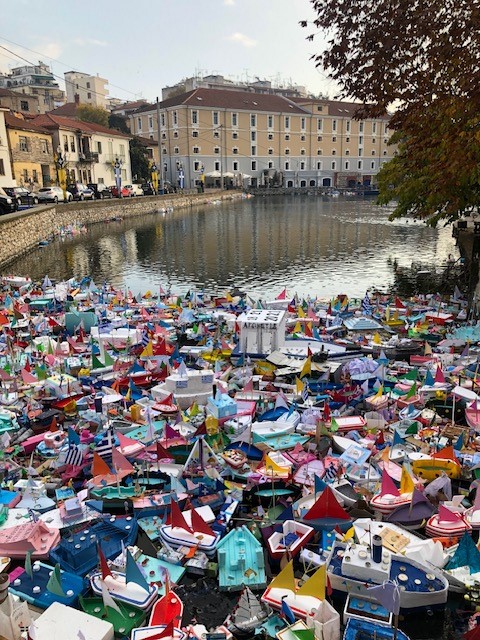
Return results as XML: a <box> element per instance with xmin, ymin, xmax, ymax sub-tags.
<box><xmin>129</xmin><ymin>88</ymin><xmax>394</xmax><ymax>188</ymax></box>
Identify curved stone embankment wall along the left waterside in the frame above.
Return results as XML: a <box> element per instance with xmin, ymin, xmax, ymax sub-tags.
<box><xmin>0</xmin><ymin>190</ymin><xmax>242</xmax><ymax>268</ymax></box>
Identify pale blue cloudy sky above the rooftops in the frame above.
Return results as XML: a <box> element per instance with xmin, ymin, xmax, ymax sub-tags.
<box><xmin>0</xmin><ymin>0</ymin><xmax>336</xmax><ymax>100</ymax></box>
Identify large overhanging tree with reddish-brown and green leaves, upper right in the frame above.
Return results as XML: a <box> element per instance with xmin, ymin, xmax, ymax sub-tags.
<box><xmin>301</xmin><ymin>0</ymin><xmax>480</xmax><ymax>225</ymax></box>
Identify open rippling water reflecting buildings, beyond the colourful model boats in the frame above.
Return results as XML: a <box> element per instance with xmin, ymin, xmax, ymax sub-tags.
<box><xmin>8</xmin><ymin>196</ymin><xmax>457</xmax><ymax>299</ymax></box>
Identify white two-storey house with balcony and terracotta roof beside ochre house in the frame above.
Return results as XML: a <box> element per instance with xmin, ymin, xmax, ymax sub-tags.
<box><xmin>34</xmin><ymin>113</ymin><xmax>132</xmax><ymax>186</ymax></box>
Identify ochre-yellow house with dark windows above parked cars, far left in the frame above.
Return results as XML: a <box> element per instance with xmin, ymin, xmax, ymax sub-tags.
<box><xmin>5</xmin><ymin>113</ymin><xmax>56</xmax><ymax>191</ymax></box>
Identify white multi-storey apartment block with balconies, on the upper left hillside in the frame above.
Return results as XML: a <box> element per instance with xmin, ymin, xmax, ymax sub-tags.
<box><xmin>0</xmin><ymin>61</ymin><xmax>65</xmax><ymax>113</ymax></box>
